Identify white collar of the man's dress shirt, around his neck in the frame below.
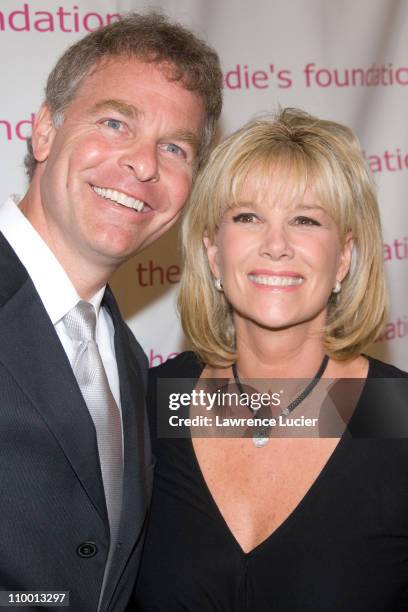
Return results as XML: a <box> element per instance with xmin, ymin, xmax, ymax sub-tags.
<box><xmin>0</xmin><ymin>196</ymin><xmax>105</xmax><ymax>325</ymax></box>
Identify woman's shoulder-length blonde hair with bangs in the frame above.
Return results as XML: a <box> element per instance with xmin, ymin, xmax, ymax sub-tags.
<box><xmin>179</xmin><ymin>108</ymin><xmax>387</xmax><ymax>366</ymax></box>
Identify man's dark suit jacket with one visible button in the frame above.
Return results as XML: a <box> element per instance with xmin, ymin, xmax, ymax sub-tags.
<box><xmin>0</xmin><ymin>234</ymin><xmax>153</xmax><ymax>612</ymax></box>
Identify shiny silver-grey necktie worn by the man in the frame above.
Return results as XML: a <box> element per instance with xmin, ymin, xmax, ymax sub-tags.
<box><xmin>64</xmin><ymin>300</ymin><xmax>123</xmax><ymax>569</ymax></box>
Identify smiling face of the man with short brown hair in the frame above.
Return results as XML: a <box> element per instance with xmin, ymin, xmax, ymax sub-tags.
<box><xmin>27</xmin><ymin>58</ymin><xmax>204</xmax><ymax>271</ymax></box>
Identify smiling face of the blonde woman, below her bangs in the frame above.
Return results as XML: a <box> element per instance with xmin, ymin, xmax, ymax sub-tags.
<box><xmin>204</xmin><ymin>177</ymin><xmax>352</xmax><ymax>332</ymax></box>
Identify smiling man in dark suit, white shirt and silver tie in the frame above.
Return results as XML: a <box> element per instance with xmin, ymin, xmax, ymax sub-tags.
<box><xmin>0</xmin><ymin>14</ymin><xmax>221</xmax><ymax>612</ymax></box>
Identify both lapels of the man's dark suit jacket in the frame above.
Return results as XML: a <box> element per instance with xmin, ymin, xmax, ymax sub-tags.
<box><xmin>0</xmin><ymin>233</ymin><xmax>151</xmax><ymax>609</ymax></box>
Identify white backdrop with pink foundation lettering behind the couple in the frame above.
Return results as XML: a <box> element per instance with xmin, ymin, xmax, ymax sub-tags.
<box><xmin>0</xmin><ymin>0</ymin><xmax>408</xmax><ymax>370</ymax></box>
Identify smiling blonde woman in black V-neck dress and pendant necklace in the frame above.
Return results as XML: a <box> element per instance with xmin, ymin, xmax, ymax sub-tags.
<box><xmin>135</xmin><ymin>109</ymin><xmax>408</xmax><ymax>612</ymax></box>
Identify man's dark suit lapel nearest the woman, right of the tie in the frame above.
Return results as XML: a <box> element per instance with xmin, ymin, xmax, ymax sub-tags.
<box><xmin>104</xmin><ymin>288</ymin><xmax>151</xmax><ymax>604</ymax></box>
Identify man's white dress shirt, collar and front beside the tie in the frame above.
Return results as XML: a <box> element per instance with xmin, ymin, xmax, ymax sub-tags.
<box><xmin>0</xmin><ymin>196</ymin><xmax>121</xmax><ymax>409</ymax></box>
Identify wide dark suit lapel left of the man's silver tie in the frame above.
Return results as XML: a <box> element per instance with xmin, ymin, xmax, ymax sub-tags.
<box><xmin>0</xmin><ymin>239</ymin><xmax>107</xmax><ymax>521</ymax></box>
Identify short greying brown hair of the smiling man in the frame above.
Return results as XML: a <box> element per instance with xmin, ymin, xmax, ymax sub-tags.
<box><xmin>24</xmin><ymin>12</ymin><xmax>222</xmax><ymax>180</ymax></box>
